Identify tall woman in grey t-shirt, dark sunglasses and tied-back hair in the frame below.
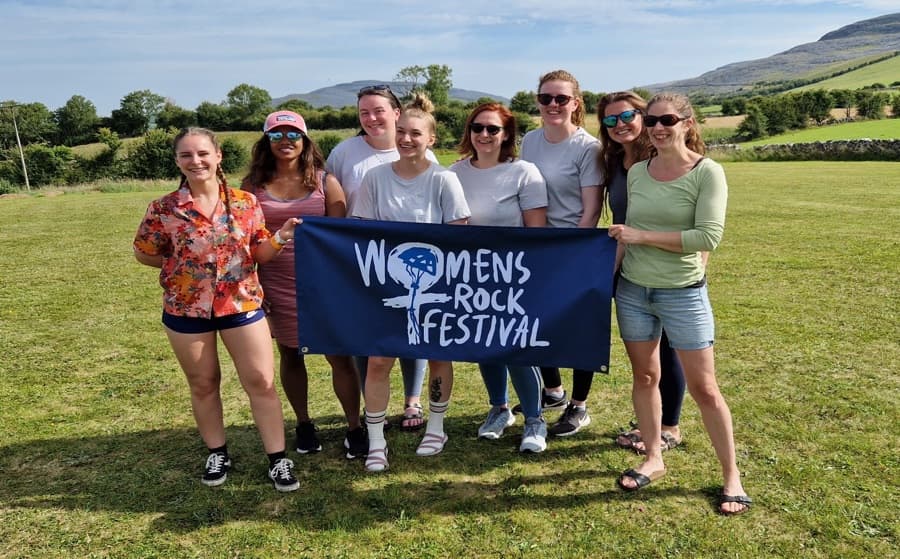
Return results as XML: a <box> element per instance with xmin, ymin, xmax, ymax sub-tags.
<box><xmin>514</xmin><ymin>70</ymin><xmax>601</xmax><ymax>437</ymax></box>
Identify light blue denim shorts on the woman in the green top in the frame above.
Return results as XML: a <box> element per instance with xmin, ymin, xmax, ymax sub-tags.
<box><xmin>616</xmin><ymin>278</ymin><xmax>716</xmax><ymax>350</ymax></box>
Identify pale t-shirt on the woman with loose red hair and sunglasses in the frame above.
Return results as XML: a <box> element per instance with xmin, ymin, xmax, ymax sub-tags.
<box><xmin>450</xmin><ymin>159</ymin><xmax>547</xmax><ymax>227</ymax></box>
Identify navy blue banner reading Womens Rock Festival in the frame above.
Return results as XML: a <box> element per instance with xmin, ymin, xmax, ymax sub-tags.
<box><xmin>294</xmin><ymin>217</ymin><xmax>616</xmax><ymax>371</ymax></box>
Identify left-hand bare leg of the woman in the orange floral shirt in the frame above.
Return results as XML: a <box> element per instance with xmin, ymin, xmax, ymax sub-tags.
<box><xmin>166</xmin><ymin>328</ymin><xmax>225</xmax><ymax>448</ymax></box>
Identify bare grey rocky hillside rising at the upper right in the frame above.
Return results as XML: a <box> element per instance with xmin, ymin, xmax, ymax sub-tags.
<box><xmin>643</xmin><ymin>13</ymin><xmax>900</xmax><ymax>94</ymax></box>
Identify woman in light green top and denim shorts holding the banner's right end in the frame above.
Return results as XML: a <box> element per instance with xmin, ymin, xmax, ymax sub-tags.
<box><xmin>609</xmin><ymin>93</ymin><xmax>751</xmax><ymax>515</ymax></box>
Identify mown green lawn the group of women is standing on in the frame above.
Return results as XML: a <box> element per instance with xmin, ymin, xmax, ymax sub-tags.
<box><xmin>0</xmin><ymin>163</ymin><xmax>900</xmax><ymax>559</ymax></box>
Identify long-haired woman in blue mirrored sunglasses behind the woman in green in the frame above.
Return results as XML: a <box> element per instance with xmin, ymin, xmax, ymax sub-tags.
<box><xmin>597</xmin><ymin>91</ymin><xmax>692</xmax><ymax>460</ymax></box>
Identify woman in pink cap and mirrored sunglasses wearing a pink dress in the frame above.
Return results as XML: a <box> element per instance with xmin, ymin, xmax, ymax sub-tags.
<box><xmin>241</xmin><ymin>111</ymin><xmax>368</xmax><ymax>459</ymax></box>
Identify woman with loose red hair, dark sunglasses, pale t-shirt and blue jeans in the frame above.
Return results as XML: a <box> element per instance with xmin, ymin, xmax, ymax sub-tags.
<box><xmin>450</xmin><ymin>103</ymin><xmax>547</xmax><ymax>453</ymax></box>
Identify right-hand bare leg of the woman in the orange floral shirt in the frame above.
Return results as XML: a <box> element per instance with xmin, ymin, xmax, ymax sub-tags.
<box><xmin>219</xmin><ymin>320</ymin><xmax>284</xmax><ymax>454</ymax></box>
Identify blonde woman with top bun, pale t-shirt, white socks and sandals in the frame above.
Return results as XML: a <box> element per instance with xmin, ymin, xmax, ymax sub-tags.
<box><xmin>350</xmin><ymin>95</ymin><xmax>470</xmax><ymax>472</ymax></box>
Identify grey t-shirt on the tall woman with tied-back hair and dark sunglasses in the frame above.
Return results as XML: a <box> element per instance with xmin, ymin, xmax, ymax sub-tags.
<box><xmin>522</xmin><ymin>127</ymin><xmax>601</xmax><ymax>227</ymax></box>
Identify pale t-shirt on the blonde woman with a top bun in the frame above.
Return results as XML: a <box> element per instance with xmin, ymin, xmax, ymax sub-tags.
<box><xmin>350</xmin><ymin>163</ymin><xmax>471</xmax><ymax>223</ymax></box>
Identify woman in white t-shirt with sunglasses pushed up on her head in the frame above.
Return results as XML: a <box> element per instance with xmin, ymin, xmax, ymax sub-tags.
<box><xmin>325</xmin><ymin>85</ymin><xmax>437</xmax><ymax>431</ymax></box>
